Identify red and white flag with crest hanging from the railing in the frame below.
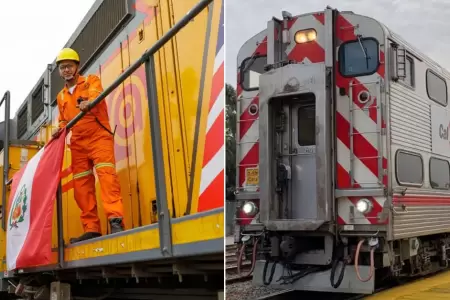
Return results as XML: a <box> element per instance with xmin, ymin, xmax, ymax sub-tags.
<box><xmin>6</xmin><ymin>129</ymin><xmax>66</xmax><ymax>271</ymax></box>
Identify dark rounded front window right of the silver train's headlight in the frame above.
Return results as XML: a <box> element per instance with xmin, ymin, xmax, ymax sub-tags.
<box><xmin>339</xmin><ymin>38</ymin><xmax>379</xmax><ymax>77</ymax></box>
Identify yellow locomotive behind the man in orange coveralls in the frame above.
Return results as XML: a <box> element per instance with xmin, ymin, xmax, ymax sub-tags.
<box><xmin>0</xmin><ymin>0</ymin><xmax>224</xmax><ymax>300</ymax></box>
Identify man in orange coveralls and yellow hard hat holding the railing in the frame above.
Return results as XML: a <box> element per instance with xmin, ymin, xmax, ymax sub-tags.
<box><xmin>53</xmin><ymin>48</ymin><xmax>123</xmax><ymax>243</ymax></box>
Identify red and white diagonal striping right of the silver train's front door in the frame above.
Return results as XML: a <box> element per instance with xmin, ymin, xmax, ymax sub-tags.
<box><xmin>336</xmin><ymin>14</ymin><xmax>387</xmax><ymax>224</ymax></box>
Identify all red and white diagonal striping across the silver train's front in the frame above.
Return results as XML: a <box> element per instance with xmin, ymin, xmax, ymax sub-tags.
<box><xmin>238</xmin><ymin>13</ymin><xmax>387</xmax><ymax>224</ymax></box>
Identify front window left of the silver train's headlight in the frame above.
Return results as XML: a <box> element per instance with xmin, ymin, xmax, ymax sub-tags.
<box><xmin>240</xmin><ymin>56</ymin><xmax>267</xmax><ymax>91</ymax></box>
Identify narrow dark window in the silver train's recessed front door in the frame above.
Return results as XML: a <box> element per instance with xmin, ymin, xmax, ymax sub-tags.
<box><xmin>297</xmin><ymin>105</ymin><xmax>316</xmax><ymax>146</ymax></box>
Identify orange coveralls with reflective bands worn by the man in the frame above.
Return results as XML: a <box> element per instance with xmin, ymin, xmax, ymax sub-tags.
<box><xmin>57</xmin><ymin>75</ymin><xmax>123</xmax><ymax>232</ymax></box>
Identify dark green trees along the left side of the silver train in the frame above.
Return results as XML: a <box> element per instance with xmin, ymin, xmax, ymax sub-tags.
<box><xmin>225</xmin><ymin>83</ymin><xmax>237</xmax><ymax>199</ymax></box>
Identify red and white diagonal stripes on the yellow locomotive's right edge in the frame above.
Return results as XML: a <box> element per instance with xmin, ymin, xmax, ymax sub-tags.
<box><xmin>198</xmin><ymin>1</ymin><xmax>225</xmax><ymax>212</ymax></box>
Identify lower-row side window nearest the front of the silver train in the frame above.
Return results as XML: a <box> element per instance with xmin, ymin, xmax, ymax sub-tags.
<box><xmin>395</xmin><ymin>150</ymin><xmax>423</xmax><ymax>185</ymax></box>
